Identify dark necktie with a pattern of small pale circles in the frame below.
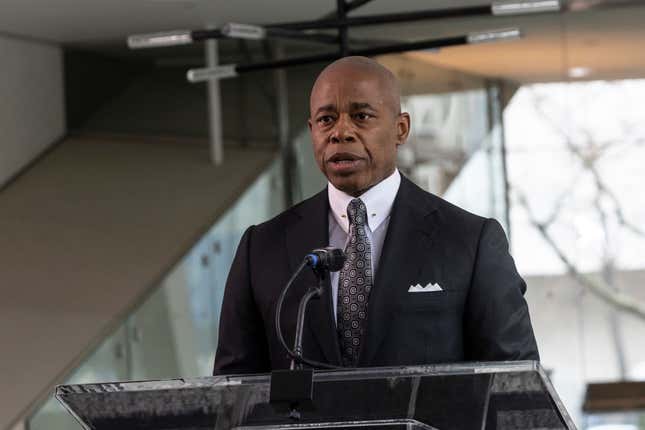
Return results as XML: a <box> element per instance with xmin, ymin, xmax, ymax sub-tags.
<box><xmin>336</xmin><ymin>199</ymin><xmax>373</xmax><ymax>366</ymax></box>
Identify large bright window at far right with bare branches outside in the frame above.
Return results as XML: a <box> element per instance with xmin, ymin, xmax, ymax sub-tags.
<box><xmin>505</xmin><ymin>80</ymin><xmax>645</xmax><ymax>429</ymax></box>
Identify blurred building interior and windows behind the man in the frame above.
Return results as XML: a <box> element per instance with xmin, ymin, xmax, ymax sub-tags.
<box><xmin>0</xmin><ymin>0</ymin><xmax>645</xmax><ymax>430</ymax></box>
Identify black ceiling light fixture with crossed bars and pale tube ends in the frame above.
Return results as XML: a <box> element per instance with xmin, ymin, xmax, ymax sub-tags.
<box><xmin>128</xmin><ymin>0</ymin><xmax>532</xmax><ymax>82</ymax></box>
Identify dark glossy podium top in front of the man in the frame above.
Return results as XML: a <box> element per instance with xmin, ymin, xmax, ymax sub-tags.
<box><xmin>56</xmin><ymin>361</ymin><xmax>575</xmax><ymax>430</ymax></box>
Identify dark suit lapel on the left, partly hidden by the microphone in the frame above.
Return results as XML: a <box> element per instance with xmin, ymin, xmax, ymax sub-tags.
<box><xmin>286</xmin><ymin>189</ymin><xmax>340</xmax><ymax>364</ymax></box>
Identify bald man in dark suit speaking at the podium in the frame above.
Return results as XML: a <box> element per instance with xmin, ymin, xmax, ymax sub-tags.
<box><xmin>214</xmin><ymin>57</ymin><xmax>539</xmax><ymax>374</ymax></box>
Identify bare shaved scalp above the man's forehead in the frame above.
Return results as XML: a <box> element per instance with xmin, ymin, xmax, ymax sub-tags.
<box><xmin>310</xmin><ymin>56</ymin><xmax>401</xmax><ymax>115</ymax></box>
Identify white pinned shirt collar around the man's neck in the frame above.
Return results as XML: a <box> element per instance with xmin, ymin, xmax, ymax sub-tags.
<box><xmin>327</xmin><ymin>169</ymin><xmax>401</xmax><ymax>234</ymax></box>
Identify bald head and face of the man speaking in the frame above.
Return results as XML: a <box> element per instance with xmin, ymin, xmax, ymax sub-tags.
<box><xmin>309</xmin><ymin>57</ymin><xmax>410</xmax><ymax>196</ymax></box>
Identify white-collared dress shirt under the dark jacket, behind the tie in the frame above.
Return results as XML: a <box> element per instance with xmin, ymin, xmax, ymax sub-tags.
<box><xmin>327</xmin><ymin>169</ymin><xmax>401</xmax><ymax>321</ymax></box>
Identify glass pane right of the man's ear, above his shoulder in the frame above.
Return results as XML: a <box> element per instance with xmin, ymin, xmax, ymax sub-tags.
<box><xmin>399</xmin><ymin>85</ymin><xmax>508</xmax><ymax>227</ymax></box>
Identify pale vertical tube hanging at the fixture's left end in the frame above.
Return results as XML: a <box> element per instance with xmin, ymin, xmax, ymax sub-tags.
<box><xmin>205</xmin><ymin>39</ymin><xmax>224</xmax><ymax>166</ymax></box>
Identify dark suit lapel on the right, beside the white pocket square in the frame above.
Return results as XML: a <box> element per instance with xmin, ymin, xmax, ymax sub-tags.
<box><xmin>359</xmin><ymin>176</ymin><xmax>435</xmax><ymax>366</ymax></box>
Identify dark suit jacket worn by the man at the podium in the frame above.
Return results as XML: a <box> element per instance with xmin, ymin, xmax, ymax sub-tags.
<box><xmin>214</xmin><ymin>177</ymin><xmax>539</xmax><ymax>374</ymax></box>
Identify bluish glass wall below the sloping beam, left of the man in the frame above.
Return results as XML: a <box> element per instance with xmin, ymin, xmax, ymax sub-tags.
<box><xmin>28</xmin><ymin>160</ymin><xmax>284</xmax><ymax>430</ymax></box>
